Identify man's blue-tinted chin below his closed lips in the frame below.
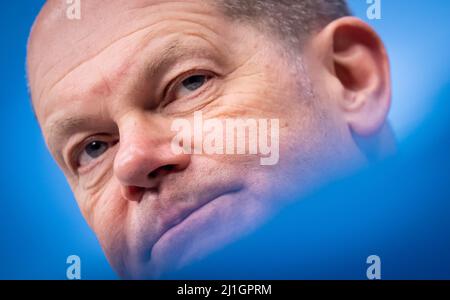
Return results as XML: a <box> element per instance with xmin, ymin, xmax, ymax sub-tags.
<box><xmin>125</xmin><ymin>190</ymin><xmax>268</xmax><ymax>279</ymax></box>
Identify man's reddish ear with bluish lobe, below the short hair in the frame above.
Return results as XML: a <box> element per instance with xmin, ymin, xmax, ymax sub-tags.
<box><xmin>314</xmin><ymin>17</ymin><xmax>391</xmax><ymax>137</ymax></box>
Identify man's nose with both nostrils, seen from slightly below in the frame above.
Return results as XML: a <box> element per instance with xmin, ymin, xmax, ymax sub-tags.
<box><xmin>114</xmin><ymin>116</ymin><xmax>190</xmax><ymax>201</ymax></box>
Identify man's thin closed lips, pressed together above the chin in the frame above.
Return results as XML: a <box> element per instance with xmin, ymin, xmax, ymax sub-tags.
<box><xmin>147</xmin><ymin>187</ymin><xmax>242</xmax><ymax>260</ymax></box>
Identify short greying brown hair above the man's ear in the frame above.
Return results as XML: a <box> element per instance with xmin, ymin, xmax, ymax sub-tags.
<box><xmin>217</xmin><ymin>0</ymin><xmax>351</xmax><ymax>44</ymax></box>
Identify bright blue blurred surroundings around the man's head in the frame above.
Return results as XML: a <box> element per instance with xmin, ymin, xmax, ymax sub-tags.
<box><xmin>0</xmin><ymin>0</ymin><xmax>450</xmax><ymax>279</ymax></box>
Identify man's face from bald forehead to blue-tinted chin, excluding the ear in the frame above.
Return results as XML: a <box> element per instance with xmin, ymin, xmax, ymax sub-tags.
<box><xmin>28</xmin><ymin>1</ymin><xmax>361</xmax><ymax>278</ymax></box>
